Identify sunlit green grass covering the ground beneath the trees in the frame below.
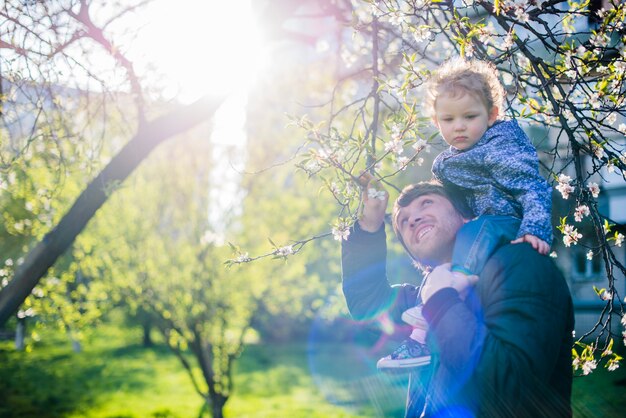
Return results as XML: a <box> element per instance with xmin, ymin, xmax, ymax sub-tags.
<box><xmin>0</xmin><ymin>326</ymin><xmax>626</xmax><ymax>418</ymax></box>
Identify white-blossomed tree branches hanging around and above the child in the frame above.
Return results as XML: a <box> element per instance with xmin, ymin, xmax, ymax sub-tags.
<box><xmin>234</xmin><ymin>0</ymin><xmax>626</xmax><ymax>374</ymax></box>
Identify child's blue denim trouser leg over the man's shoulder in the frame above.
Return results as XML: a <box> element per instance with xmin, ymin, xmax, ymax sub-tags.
<box><xmin>452</xmin><ymin>215</ymin><xmax>520</xmax><ymax>275</ymax></box>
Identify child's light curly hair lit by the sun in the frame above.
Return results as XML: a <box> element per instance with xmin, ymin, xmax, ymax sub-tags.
<box><xmin>425</xmin><ymin>58</ymin><xmax>505</xmax><ymax>116</ymax></box>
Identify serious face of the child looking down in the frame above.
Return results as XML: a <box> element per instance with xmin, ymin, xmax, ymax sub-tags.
<box><xmin>434</xmin><ymin>93</ymin><xmax>498</xmax><ymax>151</ymax></box>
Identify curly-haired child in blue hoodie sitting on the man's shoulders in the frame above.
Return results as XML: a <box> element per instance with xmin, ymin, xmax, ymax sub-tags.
<box><xmin>378</xmin><ymin>59</ymin><xmax>552</xmax><ymax>369</ymax></box>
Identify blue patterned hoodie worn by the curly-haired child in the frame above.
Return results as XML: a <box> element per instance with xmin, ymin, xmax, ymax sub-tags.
<box><xmin>432</xmin><ymin>120</ymin><xmax>552</xmax><ymax>244</ymax></box>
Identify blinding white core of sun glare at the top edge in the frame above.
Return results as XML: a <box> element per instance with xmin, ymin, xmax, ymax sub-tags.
<box><xmin>135</xmin><ymin>0</ymin><xmax>265</xmax><ymax>103</ymax></box>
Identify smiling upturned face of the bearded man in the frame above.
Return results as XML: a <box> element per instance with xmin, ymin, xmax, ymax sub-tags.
<box><xmin>396</xmin><ymin>194</ymin><xmax>467</xmax><ymax>266</ymax></box>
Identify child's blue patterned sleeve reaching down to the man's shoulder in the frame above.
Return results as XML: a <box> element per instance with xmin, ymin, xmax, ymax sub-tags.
<box><xmin>485</xmin><ymin>126</ymin><xmax>552</xmax><ymax>244</ymax></box>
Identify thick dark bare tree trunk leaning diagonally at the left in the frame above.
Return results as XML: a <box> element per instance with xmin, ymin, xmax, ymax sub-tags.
<box><xmin>0</xmin><ymin>97</ymin><xmax>224</xmax><ymax>327</ymax></box>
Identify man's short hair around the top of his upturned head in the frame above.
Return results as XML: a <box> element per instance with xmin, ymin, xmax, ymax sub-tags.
<box><xmin>391</xmin><ymin>180</ymin><xmax>474</xmax><ymax>255</ymax></box>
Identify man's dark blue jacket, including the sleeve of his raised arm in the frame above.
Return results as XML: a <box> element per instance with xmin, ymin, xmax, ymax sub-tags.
<box><xmin>342</xmin><ymin>223</ymin><xmax>574</xmax><ymax>417</ymax></box>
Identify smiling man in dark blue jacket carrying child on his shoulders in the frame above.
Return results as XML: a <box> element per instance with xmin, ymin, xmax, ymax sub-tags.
<box><xmin>342</xmin><ymin>183</ymin><xmax>574</xmax><ymax>417</ymax></box>
